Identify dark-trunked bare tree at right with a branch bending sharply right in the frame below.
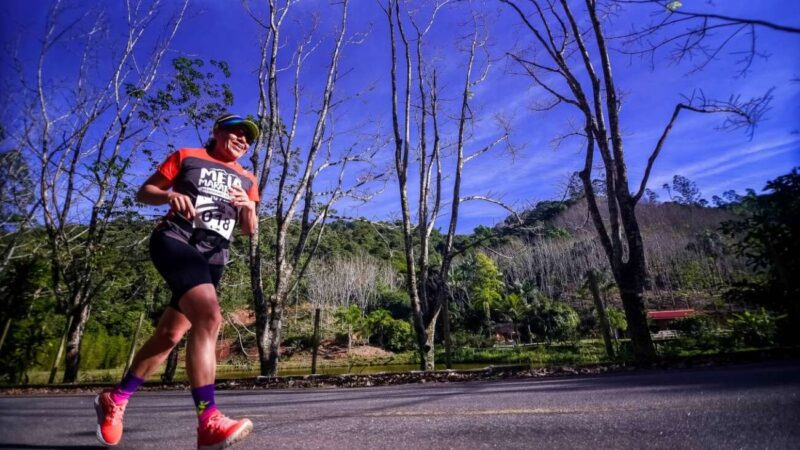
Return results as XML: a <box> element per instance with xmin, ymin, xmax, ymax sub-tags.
<box><xmin>500</xmin><ymin>0</ymin><xmax>771</xmax><ymax>360</ymax></box>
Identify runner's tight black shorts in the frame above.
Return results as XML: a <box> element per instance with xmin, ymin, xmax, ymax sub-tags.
<box><xmin>150</xmin><ymin>229</ymin><xmax>225</xmax><ymax>311</ymax></box>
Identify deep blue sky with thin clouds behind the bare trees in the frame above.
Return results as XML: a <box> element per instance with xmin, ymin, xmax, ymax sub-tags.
<box><xmin>0</xmin><ymin>0</ymin><xmax>800</xmax><ymax>233</ymax></box>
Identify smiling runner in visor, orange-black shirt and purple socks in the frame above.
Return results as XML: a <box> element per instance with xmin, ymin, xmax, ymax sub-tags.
<box><xmin>95</xmin><ymin>114</ymin><xmax>259</xmax><ymax>449</ymax></box>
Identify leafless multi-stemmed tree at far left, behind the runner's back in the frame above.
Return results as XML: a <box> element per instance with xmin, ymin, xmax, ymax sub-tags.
<box><xmin>10</xmin><ymin>0</ymin><xmax>188</xmax><ymax>382</ymax></box>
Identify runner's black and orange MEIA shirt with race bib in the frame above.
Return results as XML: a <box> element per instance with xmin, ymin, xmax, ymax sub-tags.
<box><xmin>158</xmin><ymin>148</ymin><xmax>259</xmax><ymax>264</ymax></box>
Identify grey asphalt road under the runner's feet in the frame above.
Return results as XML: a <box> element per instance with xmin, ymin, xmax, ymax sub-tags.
<box><xmin>0</xmin><ymin>361</ymin><xmax>800</xmax><ymax>450</ymax></box>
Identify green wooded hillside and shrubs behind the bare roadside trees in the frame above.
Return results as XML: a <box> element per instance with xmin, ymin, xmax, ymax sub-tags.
<box><xmin>0</xmin><ymin>170</ymin><xmax>800</xmax><ymax>384</ymax></box>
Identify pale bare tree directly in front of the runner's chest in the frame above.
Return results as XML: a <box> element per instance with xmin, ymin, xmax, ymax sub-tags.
<box><xmin>245</xmin><ymin>0</ymin><xmax>376</xmax><ymax>376</ymax></box>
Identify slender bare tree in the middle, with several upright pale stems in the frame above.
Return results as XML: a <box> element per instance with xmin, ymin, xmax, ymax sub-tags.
<box><xmin>381</xmin><ymin>0</ymin><xmax>508</xmax><ymax>370</ymax></box>
